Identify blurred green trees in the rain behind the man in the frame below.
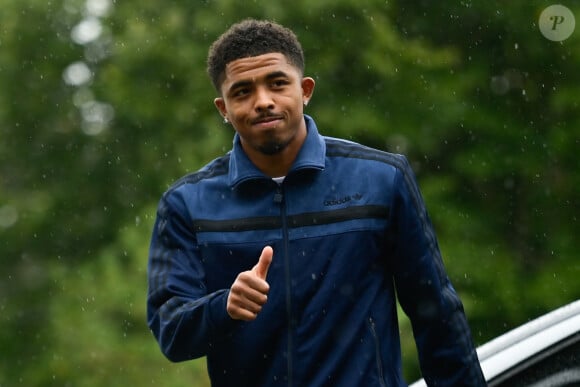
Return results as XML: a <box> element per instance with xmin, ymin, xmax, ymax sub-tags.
<box><xmin>0</xmin><ymin>0</ymin><xmax>580</xmax><ymax>386</ymax></box>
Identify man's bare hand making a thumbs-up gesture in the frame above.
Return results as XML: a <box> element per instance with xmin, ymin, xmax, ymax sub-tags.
<box><xmin>226</xmin><ymin>246</ymin><xmax>274</xmax><ymax>321</ymax></box>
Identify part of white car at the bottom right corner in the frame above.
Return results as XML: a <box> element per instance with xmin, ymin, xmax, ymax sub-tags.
<box><xmin>411</xmin><ymin>300</ymin><xmax>580</xmax><ymax>387</ymax></box>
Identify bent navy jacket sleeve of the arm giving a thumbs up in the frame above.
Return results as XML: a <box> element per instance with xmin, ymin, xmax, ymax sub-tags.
<box><xmin>147</xmin><ymin>191</ymin><xmax>236</xmax><ymax>361</ymax></box>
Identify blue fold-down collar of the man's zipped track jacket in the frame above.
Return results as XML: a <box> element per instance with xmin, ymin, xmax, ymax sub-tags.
<box><xmin>229</xmin><ymin>114</ymin><xmax>326</xmax><ymax>187</ymax></box>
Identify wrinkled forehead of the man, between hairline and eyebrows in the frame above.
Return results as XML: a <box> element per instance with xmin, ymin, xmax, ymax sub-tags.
<box><xmin>224</xmin><ymin>53</ymin><xmax>298</xmax><ymax>86</ymax></box>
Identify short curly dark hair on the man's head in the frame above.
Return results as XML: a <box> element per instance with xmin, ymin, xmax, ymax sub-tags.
<box><xmin>207</xmin><ymin>19</ymin><xmax>304</xmax><ymax>93</ymax></box>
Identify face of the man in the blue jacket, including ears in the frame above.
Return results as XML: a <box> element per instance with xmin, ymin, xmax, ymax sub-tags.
<box><xmin>214</xmin><ymin>53</ymin><xmax>314</xmax><ymax>158</ymax></box>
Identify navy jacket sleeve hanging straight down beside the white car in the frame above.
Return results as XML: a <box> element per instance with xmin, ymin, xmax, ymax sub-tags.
<box><xmin>391</xmin><ymin>157</ymin><xmax>486</xmax><ymax>386</ymax></box>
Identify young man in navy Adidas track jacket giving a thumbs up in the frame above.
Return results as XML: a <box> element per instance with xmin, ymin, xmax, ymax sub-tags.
<box><xmin>147</xmin><ymin>20</ymin><xmax>485</xmax><ymax>387</ymax></box>
